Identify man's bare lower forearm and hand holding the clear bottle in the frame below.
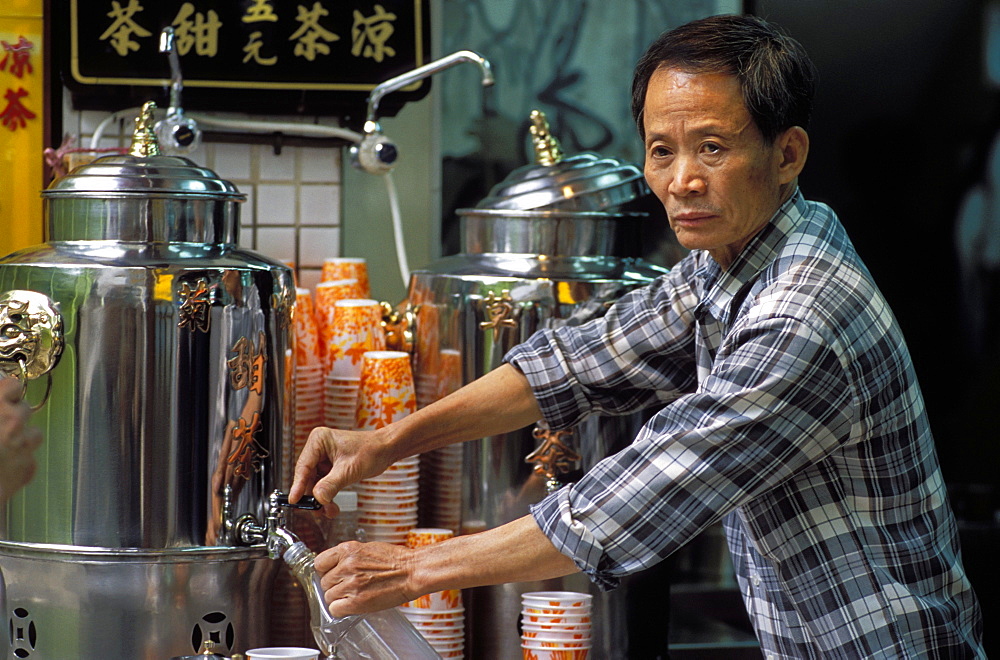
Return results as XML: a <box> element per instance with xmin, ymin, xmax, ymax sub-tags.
<box><xmin>316</xmin><ymin>516</ymin><xmax>579</xmax><ymax>616</ymax></box>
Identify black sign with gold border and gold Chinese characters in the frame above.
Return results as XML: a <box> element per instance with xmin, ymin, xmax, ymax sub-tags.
<box><xmin>52</xmin><ymin>0</ymin><xmax>430</xmax><ymax>118</ymax></box>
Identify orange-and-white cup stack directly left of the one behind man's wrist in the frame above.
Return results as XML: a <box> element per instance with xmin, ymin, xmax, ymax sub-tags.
<box><xmin>323</xmin><ymin>299</ymin><xmax>385</xmax><ymax>429</ymax></box>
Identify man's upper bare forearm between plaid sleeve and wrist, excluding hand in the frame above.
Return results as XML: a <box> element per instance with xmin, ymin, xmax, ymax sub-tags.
<box><xmin>385</xmin><ymin>364</ymin><xmax>542</xmax><ymax>459</ymax></box>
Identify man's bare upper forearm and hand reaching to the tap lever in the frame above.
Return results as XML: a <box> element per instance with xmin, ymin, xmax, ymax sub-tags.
<box><xmin>289</xmin><ymin>364</ymin><xmax>542</xmax><ymax>506</ymax></box>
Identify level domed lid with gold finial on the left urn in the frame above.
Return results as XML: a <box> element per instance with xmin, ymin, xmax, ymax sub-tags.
<box><xmin>42</xmin><ymin>102</ymin><xmax>246</xmax><ymax>201</ymax></box>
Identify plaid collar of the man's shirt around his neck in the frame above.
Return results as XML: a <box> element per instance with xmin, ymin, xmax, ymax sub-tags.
<box><xmin>695</xmin><ymin>188</ymin><xmax>806</xmax><ymax>323</ymax></box>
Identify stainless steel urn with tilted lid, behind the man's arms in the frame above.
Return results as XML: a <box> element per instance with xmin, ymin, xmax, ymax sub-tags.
<box><xmin>397</xmin><ymin>114</ymin><xmax>666</xmax><ymax>659</ymax></box>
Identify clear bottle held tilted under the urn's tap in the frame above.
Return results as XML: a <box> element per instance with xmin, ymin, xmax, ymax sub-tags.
<box><xmin>284</xmin><ymin>541</ymin><xmax>441</xmax><ymax>660</ymax></box>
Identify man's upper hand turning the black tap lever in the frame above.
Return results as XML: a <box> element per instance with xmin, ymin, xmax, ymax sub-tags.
<box><xmin>288</xmin><ymin>427</ymin><xmax>392</xmax><ymax>515</ymax></box>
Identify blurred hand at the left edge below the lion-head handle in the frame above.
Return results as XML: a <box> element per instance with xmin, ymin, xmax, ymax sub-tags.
<box><xmin>0</xmin><ymin>378</ymin><xmax>42</xmax><ymax>503</ymax></box>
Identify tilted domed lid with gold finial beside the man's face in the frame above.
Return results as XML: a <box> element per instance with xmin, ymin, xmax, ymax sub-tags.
<box><xmin>476</xmin><ymin>110</ymin><xmax>649</xmax><ymax>211</ymax></box>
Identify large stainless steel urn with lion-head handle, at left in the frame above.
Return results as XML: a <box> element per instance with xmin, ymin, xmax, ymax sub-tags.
<box><xmin>0</xmin><ymin>106</ymin><xmax>295</xmax><ymax>660</ymax></box>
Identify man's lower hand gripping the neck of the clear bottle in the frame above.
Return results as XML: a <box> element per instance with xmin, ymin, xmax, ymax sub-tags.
<box><xmin>316</xmin><ymin>541</ymin><xmax>422</xmax><ymax>617</ymax></box>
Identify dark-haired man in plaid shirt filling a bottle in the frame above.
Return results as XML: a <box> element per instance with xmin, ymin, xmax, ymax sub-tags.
<box><xmin>291</xmin><ymin>16</ymin><xmax>983</xmax><ymax>658</ymax></box>
